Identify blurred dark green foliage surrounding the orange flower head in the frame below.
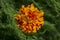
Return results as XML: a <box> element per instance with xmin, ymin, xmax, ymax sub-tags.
<box><xmin>0</xmin><ymin>0</ymin><xmax>60</xmax><ymax>40</ymax></box>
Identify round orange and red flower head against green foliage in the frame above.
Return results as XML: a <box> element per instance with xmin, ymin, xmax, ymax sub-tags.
<box><xmin>15</xmin><ymin>4</ymin><xmax>44</xmax><ymax>33</ymax></box>
